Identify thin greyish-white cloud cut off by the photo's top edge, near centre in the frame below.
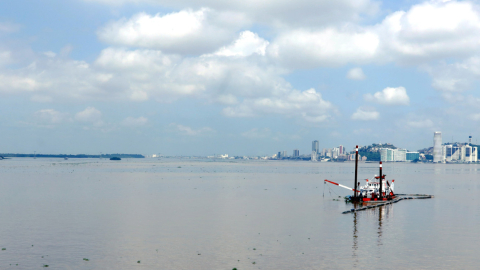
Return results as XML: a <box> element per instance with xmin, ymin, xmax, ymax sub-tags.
<box><xmin>85</xmin><ymin>0</ymin><xmax>379</xmax><ymax>27</ymax></box>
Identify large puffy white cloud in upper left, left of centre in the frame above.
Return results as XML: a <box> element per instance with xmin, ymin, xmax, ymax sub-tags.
<box><xmin>98</xmin><ymin>8</ymin><xmax>248</xmax><ymax>54</ymax></box>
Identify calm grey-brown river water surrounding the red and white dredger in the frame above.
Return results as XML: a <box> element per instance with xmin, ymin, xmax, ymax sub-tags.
<box><xmin>0</xmin><ymin>158</ymin><xmax>480</xmax><ymax>270</ymax></box>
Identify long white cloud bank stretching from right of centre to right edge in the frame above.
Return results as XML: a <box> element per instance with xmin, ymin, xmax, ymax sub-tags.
<box><xmin>267</xmin><ymin>1</ymin><xmax>480</xmax><ymax>68</ymax></box>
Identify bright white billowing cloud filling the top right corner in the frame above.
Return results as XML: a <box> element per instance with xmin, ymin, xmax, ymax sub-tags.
<box><xmin>377</xmin><ymin>1</ymin><xmax>480</xmax><ymax>62</ymax></box>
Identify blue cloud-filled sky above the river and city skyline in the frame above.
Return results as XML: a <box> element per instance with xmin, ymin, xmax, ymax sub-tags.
<box><xmin>0</xmin><ymin>0</ymin><xmax>480</xmax><ymax>155</ymax></box>
